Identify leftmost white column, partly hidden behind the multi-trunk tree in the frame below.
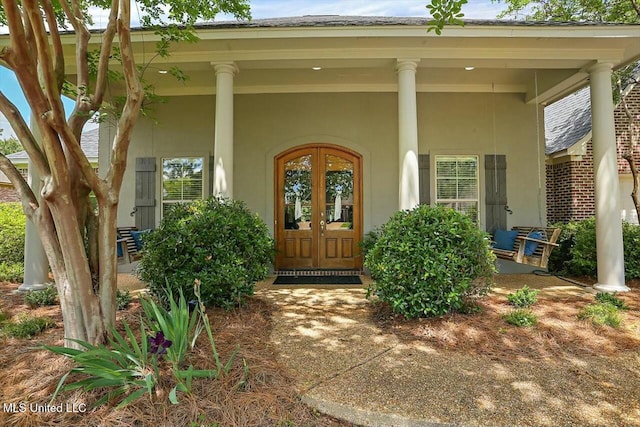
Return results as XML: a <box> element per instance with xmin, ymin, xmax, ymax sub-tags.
<box><xmin>18</xmin><ymin>120</ymin><xmax>49</xmax><ymax>291</ymax></box>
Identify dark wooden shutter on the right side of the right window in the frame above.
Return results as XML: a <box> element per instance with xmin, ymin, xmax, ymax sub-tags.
<box><xmin>484</xmin><ymin>154</ymin><xmax>507</xmax><ymax>234</ymax></box>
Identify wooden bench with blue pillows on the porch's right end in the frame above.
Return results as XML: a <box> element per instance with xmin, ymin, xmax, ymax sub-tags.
<box><xmin>492</xmin><ymin>226</ymin><xmax>562</xmax><ymax>268</ymax></box>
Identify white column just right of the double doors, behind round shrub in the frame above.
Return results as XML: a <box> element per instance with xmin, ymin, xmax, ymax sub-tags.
<box><xmin>397</xmin><ymin>59</ymin><xmax>420</xmax><ymax>210</ymax></box>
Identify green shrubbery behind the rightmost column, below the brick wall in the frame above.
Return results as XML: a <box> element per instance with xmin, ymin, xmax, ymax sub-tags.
<box><xmin>549</xmin><ymin>218</ymin><xmax>640</xmax><ymax>279</ymax></box>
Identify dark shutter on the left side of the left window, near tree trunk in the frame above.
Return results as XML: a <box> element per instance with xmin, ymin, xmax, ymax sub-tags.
<box><xmin>135</xmin><ymin>157</ymin><xmax>156</xmax><ymax>230</ymax></box>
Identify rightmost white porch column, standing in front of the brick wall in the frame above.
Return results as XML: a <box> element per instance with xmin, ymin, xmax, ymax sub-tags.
<box><xmin>589</xmin><ymin>63</ymin><xmax>629</xmax><ymax>292</ymax></box>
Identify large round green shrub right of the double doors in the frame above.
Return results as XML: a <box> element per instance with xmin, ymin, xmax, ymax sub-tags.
<box><xmin>365</xmin><ymin>205</ymin><xmax>495</xmax><ymax>318</ymax></box>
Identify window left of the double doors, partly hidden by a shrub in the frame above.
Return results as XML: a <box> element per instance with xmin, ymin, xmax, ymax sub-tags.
<box><xmin>162</xmin><ymin>157</ymin><xmax>204</xmax><ymax>215</ymax></box>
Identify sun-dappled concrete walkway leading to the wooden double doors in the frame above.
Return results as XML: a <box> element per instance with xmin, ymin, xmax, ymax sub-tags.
<box><xmin>257</xmin><ymin>275</ymin><xmax>636</xmax><ymax>427</ymax></box>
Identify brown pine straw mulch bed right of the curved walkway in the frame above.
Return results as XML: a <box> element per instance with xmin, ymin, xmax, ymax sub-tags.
<box><xmin>372</xmin><ymin>278</ymin><xmax>640</xmax><ymax>361</ymax></box>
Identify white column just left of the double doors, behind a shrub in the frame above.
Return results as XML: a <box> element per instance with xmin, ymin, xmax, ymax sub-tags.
<box><xmin>212</xmin><ymin>63</ymin><xmax>238</xmax><ymax>197</ymax></box>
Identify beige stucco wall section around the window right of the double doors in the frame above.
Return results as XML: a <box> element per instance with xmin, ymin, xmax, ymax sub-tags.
<box><xmin>418</xmin><ymin>93</ymin><xmax>546</xmax><ymax>228</ymax></box>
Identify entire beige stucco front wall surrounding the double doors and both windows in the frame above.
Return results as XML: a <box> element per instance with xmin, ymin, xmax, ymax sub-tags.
<box><xmin>112</xmin><ymin>93</ymin><xmax>545</xmax><ymax>232</ymax></box>
